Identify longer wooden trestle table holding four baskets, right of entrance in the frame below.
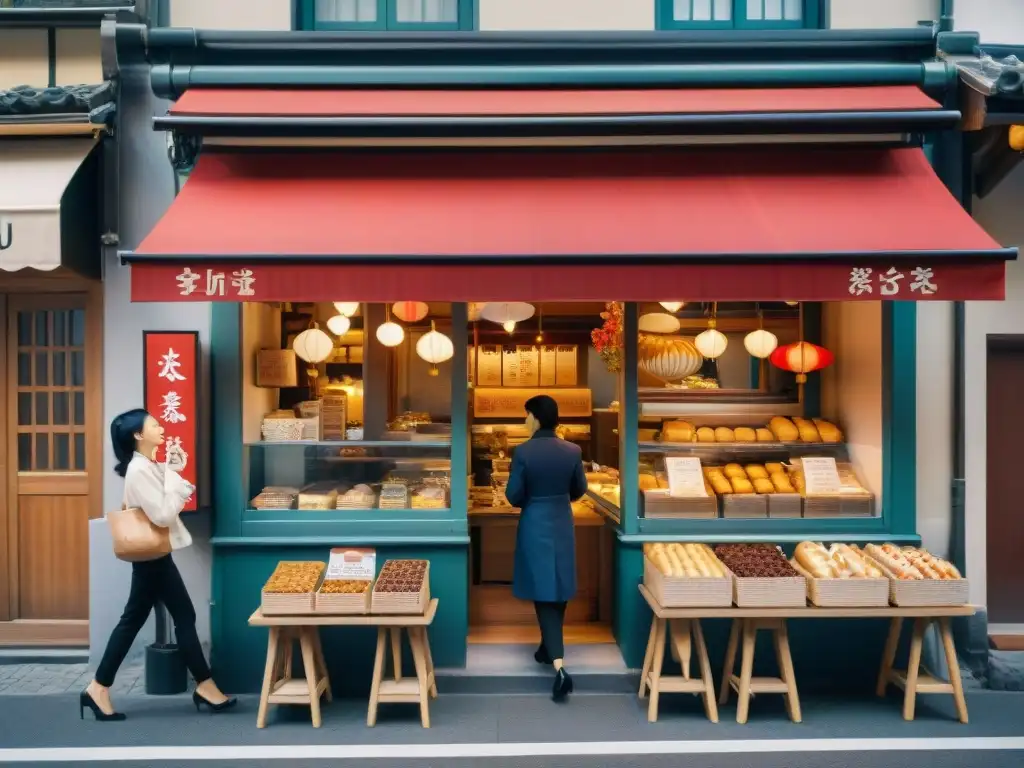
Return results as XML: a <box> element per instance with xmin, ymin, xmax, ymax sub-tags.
<box><xmin>640</xmin><ymin>585</ymin><xmax>976</xmax><ymax>723</ymax></box>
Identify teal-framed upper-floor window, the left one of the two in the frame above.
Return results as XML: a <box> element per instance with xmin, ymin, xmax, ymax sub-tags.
<box><xmin>299</xmin><ymin>0</ymin><xmax>474</xmax><ymax>32</ymax></box>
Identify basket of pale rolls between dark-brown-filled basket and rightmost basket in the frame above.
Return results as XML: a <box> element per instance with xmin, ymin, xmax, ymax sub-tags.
<box><xmin>790</xmin><ymin>542</ymin><xmax>889</xmax><ymax>608</ymax></box>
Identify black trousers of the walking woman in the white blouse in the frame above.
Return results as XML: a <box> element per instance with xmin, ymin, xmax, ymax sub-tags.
<box><xmin>96</xmin><ymin>555</ymin><xmax>210</xmax><ymax>687</ymax></box>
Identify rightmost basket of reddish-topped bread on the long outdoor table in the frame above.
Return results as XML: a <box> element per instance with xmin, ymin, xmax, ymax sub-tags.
<box><xmin>864</xmin><ymin>543</ymin><xmax>970</xmax><ymax>606</ymax></box>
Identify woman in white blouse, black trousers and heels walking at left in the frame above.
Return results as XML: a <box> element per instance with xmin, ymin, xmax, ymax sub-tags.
<box><xmin>79</xmin><ymin>409</ymin><xmax>237</xmax><ymax>721</ymax></box>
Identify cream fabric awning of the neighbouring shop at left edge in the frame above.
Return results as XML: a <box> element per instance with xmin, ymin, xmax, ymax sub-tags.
<box><xmin>0</xmin><ymin>138</ymin><xmax>99</xmax><ymax>272</ymax></box>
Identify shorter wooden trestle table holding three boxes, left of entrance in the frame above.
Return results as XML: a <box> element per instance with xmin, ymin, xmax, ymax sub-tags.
<box><xmin>249</xmin><ymin>598</ymin><xmax>437</xmax><ymax>728</ymax></box>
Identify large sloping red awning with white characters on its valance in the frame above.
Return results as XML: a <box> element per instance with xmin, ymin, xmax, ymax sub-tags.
<box><xmin>123</xmin><ymin>147</ymin><xmax>1016</xmax><ymax>301</ymax></box>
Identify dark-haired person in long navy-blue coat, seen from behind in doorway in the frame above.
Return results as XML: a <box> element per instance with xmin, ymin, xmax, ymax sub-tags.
<box><xmin>505</xmin><ymin>394</ymin><xmax>587</xmax><ymax>701</ymax></box>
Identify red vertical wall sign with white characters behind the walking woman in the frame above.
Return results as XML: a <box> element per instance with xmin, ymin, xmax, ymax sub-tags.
<box><xmin>142</xmin><ymin>331</ymin><xmax>199</xmax><ymax>512</ymax></box>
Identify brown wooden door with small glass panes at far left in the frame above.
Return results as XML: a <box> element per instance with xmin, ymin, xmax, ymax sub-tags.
<box><xmin>0</xmin><ymin>284</ymin><xmax>102</xmax><ymax>646</ymax></box>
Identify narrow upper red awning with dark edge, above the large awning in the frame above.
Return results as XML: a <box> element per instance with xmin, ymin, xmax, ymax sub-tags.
<box><xmin>154</xmin><ymin>85</ymin><xmax>959</xmax><ymax>140</ymax></box>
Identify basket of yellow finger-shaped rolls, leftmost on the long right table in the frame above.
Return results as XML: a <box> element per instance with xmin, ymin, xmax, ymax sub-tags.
<box><xmin>643</xmin><ymin>542</ymin><xmax>732</xmax><ymax>608</ymax></box>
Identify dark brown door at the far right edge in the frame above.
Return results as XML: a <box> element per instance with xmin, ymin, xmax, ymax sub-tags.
<box><xmin>985</xmin><ymin>336</ymin><xmax>1024</xmax><ymax>648</ymax></box>
